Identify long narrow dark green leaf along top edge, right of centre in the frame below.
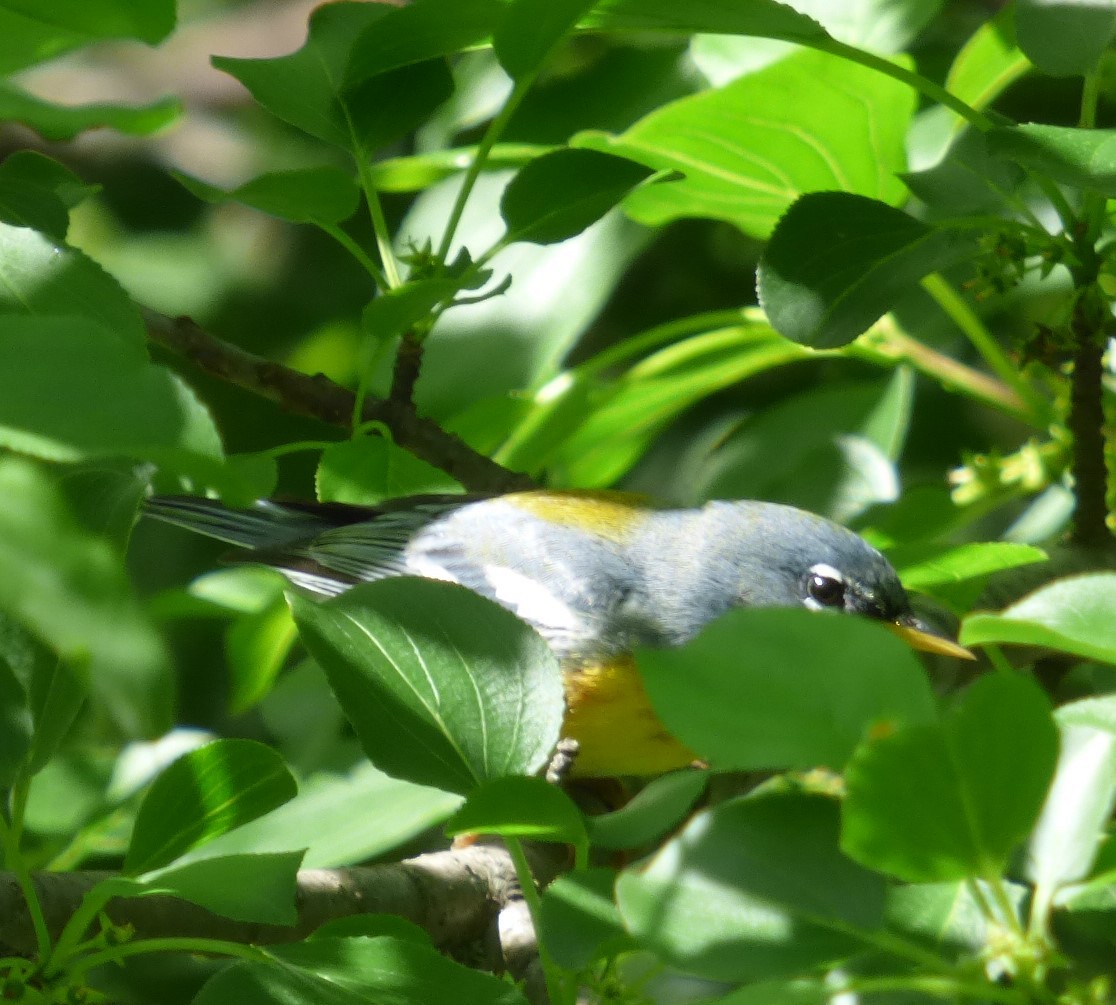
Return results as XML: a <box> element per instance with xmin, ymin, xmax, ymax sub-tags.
<box><xmin>581</xmin><ymin>0</ymin><xmax>829</xmax><ymax>46</ymax></box>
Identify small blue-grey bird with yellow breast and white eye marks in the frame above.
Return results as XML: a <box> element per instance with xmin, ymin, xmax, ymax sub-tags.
<box><xmin>146</xmin><ymin>490</ymin><xmax>973</xmax><ymax>776</ymax></box>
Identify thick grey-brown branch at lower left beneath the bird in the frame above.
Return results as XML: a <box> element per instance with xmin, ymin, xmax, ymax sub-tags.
<box><xmin>0</xmin><ymin>844</ymin><xmax>566</xmax><ymax>966</ymax></box>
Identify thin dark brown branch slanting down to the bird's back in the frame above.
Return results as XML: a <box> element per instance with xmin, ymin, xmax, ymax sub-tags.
<box><xmin>141</xmin><ymin>308</ymin><xmax>535</xmax><ymax>492</ymax></box>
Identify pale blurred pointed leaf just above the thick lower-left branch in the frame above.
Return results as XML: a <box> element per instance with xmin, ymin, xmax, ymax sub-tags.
<box><xmin>175</xmin><ymin>762</ymin><xmax>461</xmax><ymax>869</ymax></box>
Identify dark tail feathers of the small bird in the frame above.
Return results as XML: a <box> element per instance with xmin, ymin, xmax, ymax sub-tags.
<box><xmin>144</xmin><ymin>495</ymin><xmax>346</xmax><ymax>550</ymax></box>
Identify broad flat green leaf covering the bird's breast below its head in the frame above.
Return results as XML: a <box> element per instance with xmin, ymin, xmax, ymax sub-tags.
<box><xmin>637</xmin><ymin>609</ymin><xmax>934</xmax><ymax>771</ymax></box>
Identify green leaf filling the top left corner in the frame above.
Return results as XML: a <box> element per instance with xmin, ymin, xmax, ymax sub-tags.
<box><xmin>0</xmin><ymin>0</ymin><xmax>174</xmax><ymax>74</ymax></box>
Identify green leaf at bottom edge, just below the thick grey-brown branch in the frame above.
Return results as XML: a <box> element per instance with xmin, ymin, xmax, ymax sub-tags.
<box><xmin>265</xmin><ymin>937</ymin><xmax>526</xmax><ymax>1005</ymax></box>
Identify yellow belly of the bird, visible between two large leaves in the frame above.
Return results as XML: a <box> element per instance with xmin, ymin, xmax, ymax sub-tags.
<box><xmin>562</xmin><ymin>656</ymin><xmax>696</xmax><ymax>777</ymax></box>
